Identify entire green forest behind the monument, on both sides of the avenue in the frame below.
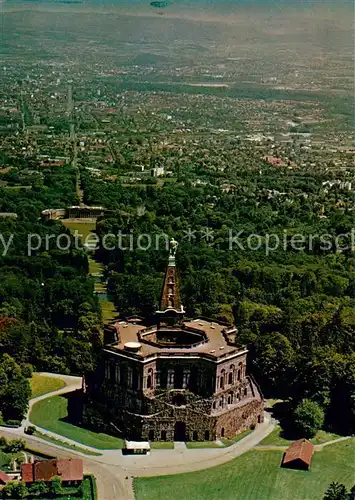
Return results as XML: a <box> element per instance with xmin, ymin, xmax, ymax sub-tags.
<box><xmin>0</xmin><ymin>140</ymin><xmax>355</xmax><ymax>432</ymax></box>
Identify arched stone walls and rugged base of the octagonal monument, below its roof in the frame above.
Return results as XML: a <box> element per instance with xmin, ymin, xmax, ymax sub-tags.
<box><xmin>85</xmin><ymin>342</ymin><xmax>263</xmax><ymax>441</ymax></box>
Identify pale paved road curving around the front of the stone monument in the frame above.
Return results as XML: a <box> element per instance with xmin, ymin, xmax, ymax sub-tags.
<box><xmin>0</xmin><ymin>373</ymin><xmax>276</xmax><ymax>500</ymax></box>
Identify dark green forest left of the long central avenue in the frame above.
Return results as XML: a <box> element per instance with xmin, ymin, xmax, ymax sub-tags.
<box><xmin>0</xmin><ymin>164</ymin><xmax>101</xmax><ymax>421</ymax></box>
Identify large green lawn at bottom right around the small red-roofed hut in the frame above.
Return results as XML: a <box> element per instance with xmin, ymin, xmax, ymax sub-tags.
<box><xmin>134</xmin><ymin>438</ymin><xmax>355</xmax><ymax>500</ymax></box>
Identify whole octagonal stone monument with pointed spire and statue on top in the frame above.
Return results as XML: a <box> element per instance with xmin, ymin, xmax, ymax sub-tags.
<box><xmin>83</xmin><ymin>240</ymin><xmax>264</xmax><ymax>441</ymax></box>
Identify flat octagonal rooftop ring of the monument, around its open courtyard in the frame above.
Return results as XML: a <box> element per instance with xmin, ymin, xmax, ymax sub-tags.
<box><xmin>106</xmin><ymin>318</ymin><xmax>246</xmax><ymax>361</ymax></box>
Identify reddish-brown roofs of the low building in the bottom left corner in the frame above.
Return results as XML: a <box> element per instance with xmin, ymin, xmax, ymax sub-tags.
<box><xmin>22</xmin><ymin>459</ymin><xmax>84</xmax><ymax>483</ymax></box>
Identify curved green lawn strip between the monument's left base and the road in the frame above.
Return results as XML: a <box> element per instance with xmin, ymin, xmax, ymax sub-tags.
<box><xmin>30</xmin><ymin>396</ymin><xmax>123</xmax><ymax>450</ymax></box>
